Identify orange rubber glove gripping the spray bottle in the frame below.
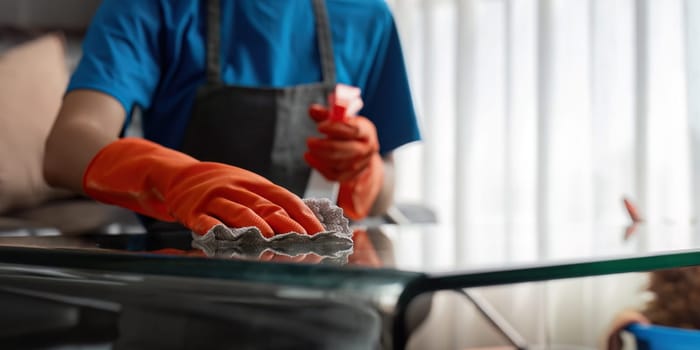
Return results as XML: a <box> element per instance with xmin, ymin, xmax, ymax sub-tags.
<box><xmin>304</xmin><ymin>105</ymin><xmax>384</xmax><ymax>220</ymax></box>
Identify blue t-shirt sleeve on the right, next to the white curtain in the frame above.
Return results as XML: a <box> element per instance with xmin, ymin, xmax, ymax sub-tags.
<box><xmin>361</xmin><ymin>9</ymin><xmax>420</xmax><ymax>154</ymax></box>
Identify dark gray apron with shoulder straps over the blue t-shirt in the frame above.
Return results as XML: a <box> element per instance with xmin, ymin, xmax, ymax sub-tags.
<box><xmin>181</xmin><ymin>0</ymin><xmax>336</xmax><ymax>196</ymax></box>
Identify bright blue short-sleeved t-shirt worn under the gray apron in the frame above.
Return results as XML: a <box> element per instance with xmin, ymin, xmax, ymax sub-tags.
<box><xmin>68</xmin><ymin>0</ymin><xmax>420</xmax><ymax>153</ymax></box>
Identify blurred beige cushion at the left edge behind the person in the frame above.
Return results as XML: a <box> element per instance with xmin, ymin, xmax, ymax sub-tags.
<box><xmin>0</xmin><ymin>34</ymin><xmax>68</xmax><ymax>213</ymax></box>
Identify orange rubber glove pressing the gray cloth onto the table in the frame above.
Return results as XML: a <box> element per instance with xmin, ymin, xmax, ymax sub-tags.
<box><xmin>83</xmin><ymin>138</ymin><xmax>323</xmax><ymax>237</ymax></box>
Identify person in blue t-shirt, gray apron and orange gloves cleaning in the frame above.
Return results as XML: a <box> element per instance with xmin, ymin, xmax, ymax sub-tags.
<box><xmin>44</xmin><ymin>0</ymin><xmax>420</xmax><ymax>236</ymax></box>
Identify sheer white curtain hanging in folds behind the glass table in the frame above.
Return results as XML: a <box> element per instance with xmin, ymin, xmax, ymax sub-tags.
<box><xmin>387</xmin><ymin>0</ymin><xmax>700</xmax><ymax>348</ymax></box>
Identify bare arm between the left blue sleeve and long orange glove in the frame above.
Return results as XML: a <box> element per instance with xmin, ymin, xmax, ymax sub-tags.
<box><xmin>44</xmin><ymin>90</ymin><xmax>126</xmax><ymax>193</ymax></box>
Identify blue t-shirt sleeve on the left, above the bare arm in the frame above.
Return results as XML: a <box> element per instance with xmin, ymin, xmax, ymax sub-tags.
<box><xmin>67</xmin><ymin>0</ymin><xmax>162</xmax><ymax>123</ymax></box>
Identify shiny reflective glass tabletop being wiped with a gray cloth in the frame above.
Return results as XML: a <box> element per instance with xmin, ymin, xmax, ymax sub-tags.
<box><xmin>0</xmin><ymin>224</ymin><xmax>700</xmax><ymax>290</ymax></box>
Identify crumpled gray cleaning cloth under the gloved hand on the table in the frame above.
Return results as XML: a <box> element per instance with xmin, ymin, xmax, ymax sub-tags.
<box><xmin>192</xmin><ymin>198</ymin><xmax>353</xmax><ymax>263</ymax></box>
